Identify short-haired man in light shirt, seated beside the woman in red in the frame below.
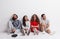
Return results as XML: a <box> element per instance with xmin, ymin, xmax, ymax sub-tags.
<box><xmin>40</xmin><ymin>14</ymin><xmax>51</xmax><ymax>34</ymax></box>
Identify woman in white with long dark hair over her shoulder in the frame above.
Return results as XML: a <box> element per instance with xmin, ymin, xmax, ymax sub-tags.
<box><xmin>22</xmin><ymin>15</ymin><xmax>30</xmax><ymax>35</ymax></box>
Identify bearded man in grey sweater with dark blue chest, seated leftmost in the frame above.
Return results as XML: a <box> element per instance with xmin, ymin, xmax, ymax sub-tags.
<box><xmin>9</xmin><ymin>14</ymin><xmax>22</xmax><ymax>33</ymax></box>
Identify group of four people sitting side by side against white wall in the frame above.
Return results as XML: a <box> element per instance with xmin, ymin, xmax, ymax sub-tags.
<box><xmin>8</xmin><ymin>14</ymin><xmax>51</xmax><ymax>35</ymax></box>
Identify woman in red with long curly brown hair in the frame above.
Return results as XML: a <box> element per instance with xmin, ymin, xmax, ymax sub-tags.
<box><xmin>30</xmin><ymin>14</ymin><xmax>40</xmax><ymax>35</ymax></box>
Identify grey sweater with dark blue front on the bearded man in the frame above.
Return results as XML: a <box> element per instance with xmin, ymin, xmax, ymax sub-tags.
<box><xmin>9</xmin><ymin>20</ymin><xmax>22</xmax><ymax>30</ymax></box>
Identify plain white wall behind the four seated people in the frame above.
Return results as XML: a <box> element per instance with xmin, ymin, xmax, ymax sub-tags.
<box><xmin>0</xmin><ymin>0</ymin><xmax>60</xmax><ymax>32</ymax></box>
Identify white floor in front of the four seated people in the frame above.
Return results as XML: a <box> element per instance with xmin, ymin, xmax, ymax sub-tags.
<box><xmin>0</xmin><ymin>32</ymin><xmax>60</xmax><ymax>39</ymax></box>
